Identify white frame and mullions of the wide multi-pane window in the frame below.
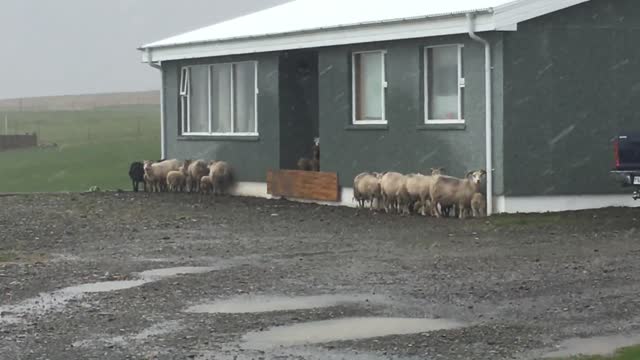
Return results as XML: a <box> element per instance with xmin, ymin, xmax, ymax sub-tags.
<box><xmin>179</xmin><ymin>60</ymin><xmax>259</xmax><ymax>137</ymax></box>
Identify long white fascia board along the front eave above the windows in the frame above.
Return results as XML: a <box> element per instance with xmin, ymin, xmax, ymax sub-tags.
<box><xmin>141</xmin><ymin>13</ymin><xmax>496</xmax><ymax>62</ymax></box>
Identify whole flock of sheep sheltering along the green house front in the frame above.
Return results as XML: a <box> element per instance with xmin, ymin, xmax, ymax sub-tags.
<box><xmin>124</xmin><ymin>144</ymin><xmax>487</xmax><ymax>219</ymax></box>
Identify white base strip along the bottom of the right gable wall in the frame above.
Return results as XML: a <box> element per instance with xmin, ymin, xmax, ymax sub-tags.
<box><xmin>494</xmin><ymin>192</ymin><xmax>640</xmax><ymax>214</ymax></box>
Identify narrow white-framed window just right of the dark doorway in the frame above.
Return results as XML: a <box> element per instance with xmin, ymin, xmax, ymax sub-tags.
<box><xmin>352</xmin><ymin>51</ymin><xmax>387</xmax><ymax>124</ymax></box>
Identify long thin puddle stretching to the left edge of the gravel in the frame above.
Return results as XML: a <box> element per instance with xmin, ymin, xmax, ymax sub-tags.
<box><xmin>0</xmin><ymin>267</ymin><xmax>217</xmax><ymax>324</ymax></box>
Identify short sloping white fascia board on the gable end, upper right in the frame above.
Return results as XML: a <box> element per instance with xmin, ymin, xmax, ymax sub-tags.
<box><xmin>493</xmin><ymin>0</ymin><xmax>590</xmax><ymax>28</ymax></box>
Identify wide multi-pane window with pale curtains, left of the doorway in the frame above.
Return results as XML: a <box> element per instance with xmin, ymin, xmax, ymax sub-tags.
<box><xmin>180</xmin><ymin>61</ymin><xmax>258</xmax><ymax>135</ymax></box>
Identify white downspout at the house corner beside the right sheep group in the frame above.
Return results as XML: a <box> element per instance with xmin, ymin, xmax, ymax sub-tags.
<box><xmin>467</xmin><ymin>13</ymin><xmax>493</xmax><ymax>215</ymax></box>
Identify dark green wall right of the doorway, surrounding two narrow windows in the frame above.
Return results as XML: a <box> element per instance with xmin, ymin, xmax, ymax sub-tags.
<box><xmin>318</xmin><ymin>33</ymin><xmax>502</xmax><ymax>188</ymax></box>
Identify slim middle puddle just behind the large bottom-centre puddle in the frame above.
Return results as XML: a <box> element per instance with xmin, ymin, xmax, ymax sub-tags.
<box><xmin>185</xmin><ymin>294</ymin><xmax>386</xmax><ymax>314</ymax></box>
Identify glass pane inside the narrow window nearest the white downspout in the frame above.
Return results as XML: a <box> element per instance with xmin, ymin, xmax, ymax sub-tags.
<box><xmin>427</xmin><ymin>46</ymin><xmax>459</xmax><ymax>120</ymax></box>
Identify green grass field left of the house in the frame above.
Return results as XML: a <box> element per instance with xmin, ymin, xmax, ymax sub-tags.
<box><xmin>0</xmin><ymin>105</ymin><xmax>160</xmax><ymax>193</ymax></box>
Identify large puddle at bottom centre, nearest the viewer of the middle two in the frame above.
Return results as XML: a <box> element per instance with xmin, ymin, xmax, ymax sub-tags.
<box><xmin>243</xmin><ymin>317</ymin><xmax>465</xmax><ymax>349</ymax></box>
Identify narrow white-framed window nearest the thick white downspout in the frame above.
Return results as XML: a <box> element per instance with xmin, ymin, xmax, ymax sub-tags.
<box><xmin>424</xmin><ymin>45</ymin><xmax>464</xmax><ymax>124</ymax></box>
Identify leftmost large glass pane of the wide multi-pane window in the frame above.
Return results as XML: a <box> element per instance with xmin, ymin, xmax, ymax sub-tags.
<box><xmin>190</xmin><ymin>65</ymin><xmax>209</xmax><ymax>132</ymax></box>
